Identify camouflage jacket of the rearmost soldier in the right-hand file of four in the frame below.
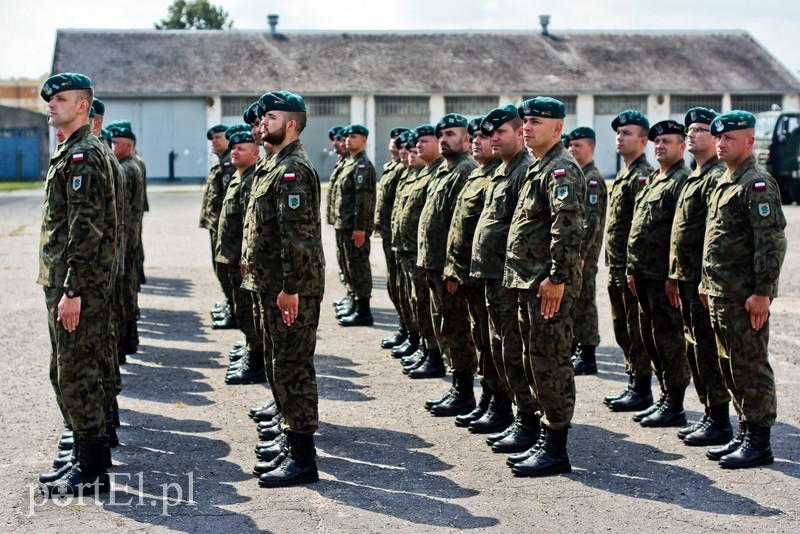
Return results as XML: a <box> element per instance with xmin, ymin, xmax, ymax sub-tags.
<box><xmin>606</xmin><ymin>154</ymin><xmax>654</xmax><ymax>269</ymax></box>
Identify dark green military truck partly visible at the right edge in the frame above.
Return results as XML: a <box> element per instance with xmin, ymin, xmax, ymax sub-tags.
<box><xmin>754</xmin><ymin>108</ymin><xmax>800</xmax><ymax>204</ymax></box>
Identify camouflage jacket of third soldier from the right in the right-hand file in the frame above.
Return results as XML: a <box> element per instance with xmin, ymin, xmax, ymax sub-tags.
<box><xmin>628</xmin><ymin>158</ymin><xmax>689</xmax><ymax>280</ymax></box>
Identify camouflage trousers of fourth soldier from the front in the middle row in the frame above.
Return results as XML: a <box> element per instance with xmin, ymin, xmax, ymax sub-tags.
<box><xmin>426</xmin><ymin>269</ymin><xmax>478</xmax><ymax>376</ymax></box>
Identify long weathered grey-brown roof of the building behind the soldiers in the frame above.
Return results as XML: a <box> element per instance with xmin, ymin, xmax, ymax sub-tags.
<box><xmin>53</xmin><ymin>30</ymin><xmax>800</xmax><ymax>97</ymax></box>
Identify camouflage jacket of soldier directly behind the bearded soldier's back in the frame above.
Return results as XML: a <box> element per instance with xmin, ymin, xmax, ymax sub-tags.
<box><xmin>215</xmin><ymin>163</ymin><xmax>257</xmax><ymax>265</ymax></box>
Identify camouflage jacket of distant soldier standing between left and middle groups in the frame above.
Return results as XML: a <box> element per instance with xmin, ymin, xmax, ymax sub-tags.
<box><xmin>333</xmin><ymin>151</ymin><xmax>375</xmax><ymax>235</ymax></box>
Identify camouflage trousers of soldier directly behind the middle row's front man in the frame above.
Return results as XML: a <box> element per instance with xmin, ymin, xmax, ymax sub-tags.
<box><xmin>486</xmin><ymin>280</ymin><xmax>536</xmax><ymax>413</ymax></box>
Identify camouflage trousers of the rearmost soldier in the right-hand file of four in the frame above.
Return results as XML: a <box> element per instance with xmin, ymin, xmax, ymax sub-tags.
<box><xmin>608</xmin><ymin>267</ymin><xmax>653</xmax><ymax>384</ymax></box>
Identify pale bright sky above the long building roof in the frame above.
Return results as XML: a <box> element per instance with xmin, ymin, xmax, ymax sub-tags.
<box><xmin>0</xmin><ymin>0</ymin><xmax>800</xmax><ymax>78</ymax></box>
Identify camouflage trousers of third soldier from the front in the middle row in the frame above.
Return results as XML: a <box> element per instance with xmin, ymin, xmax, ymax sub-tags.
<box><xmin>458</xmin><ymin>279</ymin><xmax>506</xmax><ymax>392</ymax></box>
